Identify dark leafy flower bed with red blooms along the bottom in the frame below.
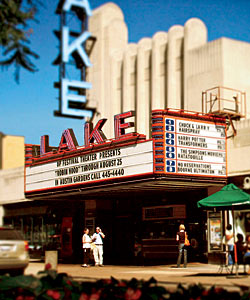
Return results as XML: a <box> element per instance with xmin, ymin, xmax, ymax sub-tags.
<box><xmin>0</xmin><ymin>270</ymin><xmax>250</xmax><ymax>300</ymax></box>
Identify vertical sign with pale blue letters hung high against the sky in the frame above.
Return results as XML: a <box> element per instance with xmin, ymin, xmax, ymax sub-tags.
<box><xmin>54</xmin><ymin>0</ymin><xmax>95</xmax><ymax>119</ymax></box>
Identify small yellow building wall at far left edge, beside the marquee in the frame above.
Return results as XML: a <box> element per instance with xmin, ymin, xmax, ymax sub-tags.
<box><xmin>1</xmin><ymin>135</ymin><xmax>24</xmax><ymax>170</ymax></box>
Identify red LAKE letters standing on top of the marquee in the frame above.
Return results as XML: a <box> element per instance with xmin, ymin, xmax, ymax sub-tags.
<box><xmin>40</xmin><ymin>111</ymin><xmax>138</xmax><ymax>155</ymax></box>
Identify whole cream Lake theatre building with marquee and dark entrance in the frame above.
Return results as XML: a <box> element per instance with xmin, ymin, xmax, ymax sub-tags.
<box><xmin>0</xmin><ymin>3</ymin><xmax>250</xmax><ymax>264</ymax></box>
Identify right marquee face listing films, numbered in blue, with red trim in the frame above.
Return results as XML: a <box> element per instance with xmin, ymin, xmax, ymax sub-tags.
<box><xmin>152</xmin><ymin>111</ymin><xmax>227</xmax><ymax>177</ymax></box>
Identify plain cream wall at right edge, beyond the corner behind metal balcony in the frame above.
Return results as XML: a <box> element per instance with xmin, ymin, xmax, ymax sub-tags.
<box><xmin>217</xmin><ymin>39</ymin><xmax>250</xmax><ymax>176</ymax></box>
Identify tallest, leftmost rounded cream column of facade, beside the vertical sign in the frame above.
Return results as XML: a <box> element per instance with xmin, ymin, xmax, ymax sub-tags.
<box><xmin>87</xmin><ymin>3</ymin><xmax>128</xmax><ymax>137</ymax></box>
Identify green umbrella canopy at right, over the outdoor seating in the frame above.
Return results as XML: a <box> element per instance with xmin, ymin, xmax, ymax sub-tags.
<box><xmin>197</xmin><ymin>183</ymin><xmax>250</xmax><ymax>209</ymax></box>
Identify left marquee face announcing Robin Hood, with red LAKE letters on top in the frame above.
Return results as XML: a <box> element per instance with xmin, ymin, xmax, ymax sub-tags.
<box><xmin>25</xmin><ymin>111</ymin><xmax>153</xmax><ymax>194</ymax></box>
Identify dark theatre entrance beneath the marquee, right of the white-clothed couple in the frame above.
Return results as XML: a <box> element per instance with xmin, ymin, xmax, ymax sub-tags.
<box><xmin>90</xmin><ymin>189</ymin><xmax>207</xmax><ymax>265</ymax></box>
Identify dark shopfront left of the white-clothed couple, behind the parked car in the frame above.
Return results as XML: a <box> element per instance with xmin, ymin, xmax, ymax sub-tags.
<box><xmin>4</xmin><ymin>201</ymin><xmax>84</xmax><ymax>261</ymax></box>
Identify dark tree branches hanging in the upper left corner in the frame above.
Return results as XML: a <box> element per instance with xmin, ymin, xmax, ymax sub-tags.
<box><xmin>0</xmin><ymin>0</ymin><xmax>39</xmax><ymax>82</ymax></box>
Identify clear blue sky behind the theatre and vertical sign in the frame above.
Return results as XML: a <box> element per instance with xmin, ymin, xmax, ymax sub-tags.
<box><xmin>0</xmin><ymin>0</ymin><xmax>250</xmax><ymax>146</ymax></box>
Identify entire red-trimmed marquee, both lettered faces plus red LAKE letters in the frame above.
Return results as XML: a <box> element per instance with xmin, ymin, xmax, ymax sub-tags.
<box><xmin>25</xmin><ymin>110</ymin><xmax>227</xmax><ymax>197</ymax></box>
